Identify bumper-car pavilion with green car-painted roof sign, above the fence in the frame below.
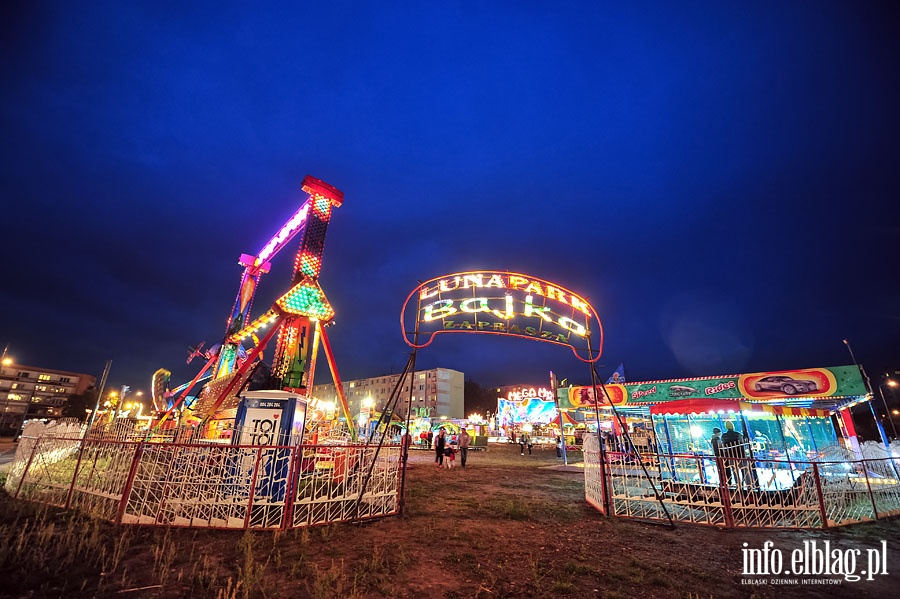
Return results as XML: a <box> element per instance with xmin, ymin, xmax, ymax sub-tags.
<box><xmin>558</xmin><ymin>366</ymin><xmax>869</xmax><ymax>455</ymax></box>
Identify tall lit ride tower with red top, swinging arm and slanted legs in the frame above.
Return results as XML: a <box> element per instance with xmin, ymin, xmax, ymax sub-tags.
<box><xmin>188</xmin><ymin>175</ymin><xmax>355</xmax><ymax>435</ymax></box>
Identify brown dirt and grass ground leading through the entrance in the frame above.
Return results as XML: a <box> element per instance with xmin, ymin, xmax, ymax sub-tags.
<box><xmin>0</xmin><ymin>446</ymin><xmax>900</xmax><ymax>599</ymax></box>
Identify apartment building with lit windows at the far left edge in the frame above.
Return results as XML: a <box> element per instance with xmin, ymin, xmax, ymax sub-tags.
<box><xmin>0</xmin><ymin>358</ymin><xmax>97</xmax><ymax>437</ymax></box>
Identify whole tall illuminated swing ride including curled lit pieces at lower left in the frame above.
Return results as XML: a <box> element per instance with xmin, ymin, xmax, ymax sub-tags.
<box><xmin>153</xmin><ymin>175</ymin><xmax>356</xmax><ymax>438</ymax></box>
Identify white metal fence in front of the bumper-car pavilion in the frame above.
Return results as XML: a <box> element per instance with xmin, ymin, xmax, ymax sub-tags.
<box><xmin>584</xmin><ymin>437</ymin><xmax>900</xmax><ymax>528</ymax></box>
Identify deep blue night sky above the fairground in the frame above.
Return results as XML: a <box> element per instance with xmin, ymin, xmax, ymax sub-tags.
<box><xmin>0</xmin><ymin>1</ymin><xmax>900</xmax><ymax>388</ymax></box>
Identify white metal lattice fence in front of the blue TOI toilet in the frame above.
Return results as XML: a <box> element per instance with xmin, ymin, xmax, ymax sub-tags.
<box><xmin>0</xmin><ymin>436</ymin><xmax>401</xmax><ymax>529</ymax></box>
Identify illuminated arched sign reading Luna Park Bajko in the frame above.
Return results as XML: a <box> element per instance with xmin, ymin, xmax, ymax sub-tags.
<box><xmin>400</xmin><ymin>270</ymin><xmax>603</xmax><ymax>363</ymax></box>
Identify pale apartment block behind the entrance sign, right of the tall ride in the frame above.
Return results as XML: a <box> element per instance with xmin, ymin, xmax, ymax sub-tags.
<box><xmin>313</xmin><ymin>368</ymin><xmax>465</xmax><ymax>420</ymax></box>
